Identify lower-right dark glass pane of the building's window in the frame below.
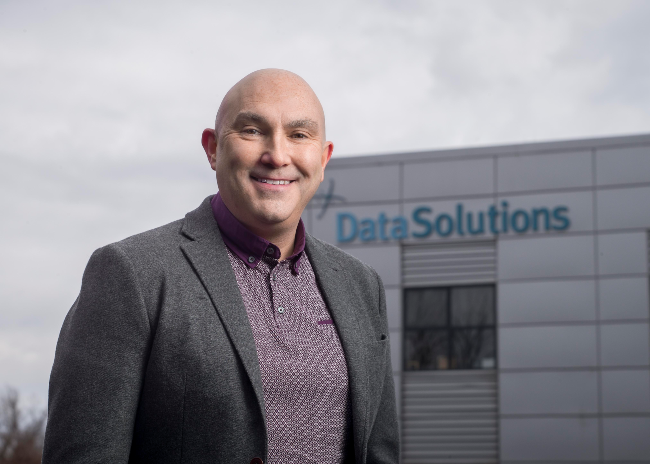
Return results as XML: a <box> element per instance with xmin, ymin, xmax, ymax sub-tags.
<box><xmin>450</xmin><ymin>329</ymin><xmax>496</xmax><ymax>369</ymax></box>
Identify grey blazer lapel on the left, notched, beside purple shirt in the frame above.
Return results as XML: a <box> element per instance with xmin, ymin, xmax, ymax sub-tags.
<box><xmin>181</xmin><ymin>197</ymin><xmax>266</xmax><ymax>425</ymax></box>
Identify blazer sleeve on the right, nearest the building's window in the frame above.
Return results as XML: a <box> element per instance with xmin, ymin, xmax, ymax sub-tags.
<box><xmin>366</xmin><ymin>273</ymin><xmax>400</xmax><ymax>464</ymax></box>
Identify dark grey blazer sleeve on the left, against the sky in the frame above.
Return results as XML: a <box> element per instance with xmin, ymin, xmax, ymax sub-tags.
<box><xmin>42</xmin><ymin>244</ymin><xmax>151</xmax><ymax>464</ymax></box>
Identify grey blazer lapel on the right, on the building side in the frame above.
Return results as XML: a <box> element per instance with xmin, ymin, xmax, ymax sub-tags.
<box><xmin>306</xmin><ymin>235</ymin><xmax>370</xmax><ymax>462</ymax></box>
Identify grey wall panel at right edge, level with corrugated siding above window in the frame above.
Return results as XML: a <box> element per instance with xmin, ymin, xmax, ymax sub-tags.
<box><xmin>598</xmin><ymin>231</ymin><xmax>650</xmax><ymax>275</ymax></box>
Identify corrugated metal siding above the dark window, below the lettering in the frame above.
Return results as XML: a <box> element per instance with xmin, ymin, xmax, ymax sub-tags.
<box><xmin>402</xmin><ymin>240</ymin><xmax>496</xmax><ymax>287</ymax></box>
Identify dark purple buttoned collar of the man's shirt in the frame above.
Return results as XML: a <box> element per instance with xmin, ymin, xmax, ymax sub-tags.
<box><xmin>210</xmin><ymin>193</ymin><xmax>305</xmax><ymax>274</ymax></box>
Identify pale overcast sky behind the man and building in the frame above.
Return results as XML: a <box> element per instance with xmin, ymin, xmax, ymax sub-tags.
<box><xmin>0</xmin><ymin>0</ymin><xmax>650</xmax><ymax>405</ymax></box>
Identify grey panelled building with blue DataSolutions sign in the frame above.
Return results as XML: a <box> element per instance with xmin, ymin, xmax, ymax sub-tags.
<box><xmin>304</xmin><ymin>135</ymin><xmax>650</xmax><ymax>463</ymax></box>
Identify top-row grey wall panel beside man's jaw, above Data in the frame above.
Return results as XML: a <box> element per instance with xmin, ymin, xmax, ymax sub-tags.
<box><xmin>312</xmin><ymin>164</ymin><xmax>399</xmax><ymax>207</ymax></box>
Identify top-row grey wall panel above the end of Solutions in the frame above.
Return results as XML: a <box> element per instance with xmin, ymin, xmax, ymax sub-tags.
<box><xmin>497</xmin><ymin>151</ymin><xmax>592</xmax><ymax>192</ymax></box>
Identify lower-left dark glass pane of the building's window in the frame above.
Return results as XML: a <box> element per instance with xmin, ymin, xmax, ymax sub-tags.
<box><xmin>404</xmin><ymin>330</ymin><xmax>449</xmax><ymax>371</ymax></box>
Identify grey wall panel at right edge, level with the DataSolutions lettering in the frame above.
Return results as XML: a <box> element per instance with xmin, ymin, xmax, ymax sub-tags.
<box><xmin>597</xmin><ymin>187</ymin><xmax>650</xmax><ymax>230</ymax></box>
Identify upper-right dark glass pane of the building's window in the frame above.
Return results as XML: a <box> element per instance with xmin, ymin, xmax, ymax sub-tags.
<box><xmin>451</xmin><ymin>285</ymin><xmax>494</xmax><ymax>327</ymax></box>
